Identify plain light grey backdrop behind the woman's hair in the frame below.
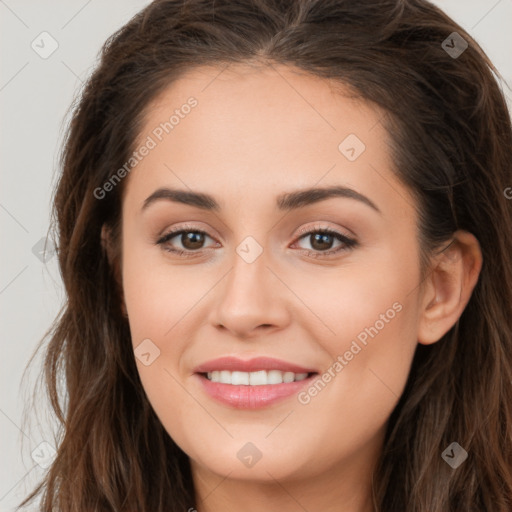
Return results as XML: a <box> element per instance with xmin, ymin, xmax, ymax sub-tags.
<box><xmin>0</xmin><ymin>0</ymin><xmax>512</xmax><ymax>512</ymax></box>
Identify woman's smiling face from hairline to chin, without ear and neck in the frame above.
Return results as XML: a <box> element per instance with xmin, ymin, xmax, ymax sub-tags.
<box><xmin>118</xmin><ymin>65</ymin><xmax>421</xmax><ymax>488</ymax></box>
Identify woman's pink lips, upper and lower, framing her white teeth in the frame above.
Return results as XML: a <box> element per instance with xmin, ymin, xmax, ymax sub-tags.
<box><xmin>194</xmin><ymin>357</ymin><xmax>318</xmax><ymax>409</ymax></box>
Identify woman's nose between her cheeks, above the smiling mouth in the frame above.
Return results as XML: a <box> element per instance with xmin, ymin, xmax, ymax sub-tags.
<box><xmin>210</xmin><ymin>250</ymin><xmax>289</xmax><ymax>339</ymax></box>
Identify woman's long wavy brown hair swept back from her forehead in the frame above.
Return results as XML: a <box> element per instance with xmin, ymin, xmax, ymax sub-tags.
<box><xmin>22</xmin><ymin>0</ymin><xmax>512</xmax><ymax>512</ymax></box>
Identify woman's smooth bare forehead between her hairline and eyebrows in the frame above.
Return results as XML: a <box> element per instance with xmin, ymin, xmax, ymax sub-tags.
<box><xmin>127</xmin><ymin>61</ymin><xmax>413</xmax><ymax>220</ymax></box>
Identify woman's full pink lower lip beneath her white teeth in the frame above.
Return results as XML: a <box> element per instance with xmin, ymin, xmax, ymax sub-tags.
<box><xmin>195</xmin><ymin>373</ymin><xmax>317</xmax><ymax>409</ymax></box>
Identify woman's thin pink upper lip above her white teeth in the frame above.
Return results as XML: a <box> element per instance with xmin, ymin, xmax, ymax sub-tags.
<box><xmin>194</xmin><ymin>356</ymin><xmax>316</xmax><ymax>373</ymax></box>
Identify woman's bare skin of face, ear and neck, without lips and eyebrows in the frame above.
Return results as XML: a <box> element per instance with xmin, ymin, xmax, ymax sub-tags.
<box><xmin>103</xmin><ymin>65</ymin><xmax>482</xmax><ymax>512</ymax></box>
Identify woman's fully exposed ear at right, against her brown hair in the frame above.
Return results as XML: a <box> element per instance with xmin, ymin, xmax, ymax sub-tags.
<box><xmin>418</xmin><ymin>230</ymin><xmax>482</xmax><ymax>345</ymax></box>
